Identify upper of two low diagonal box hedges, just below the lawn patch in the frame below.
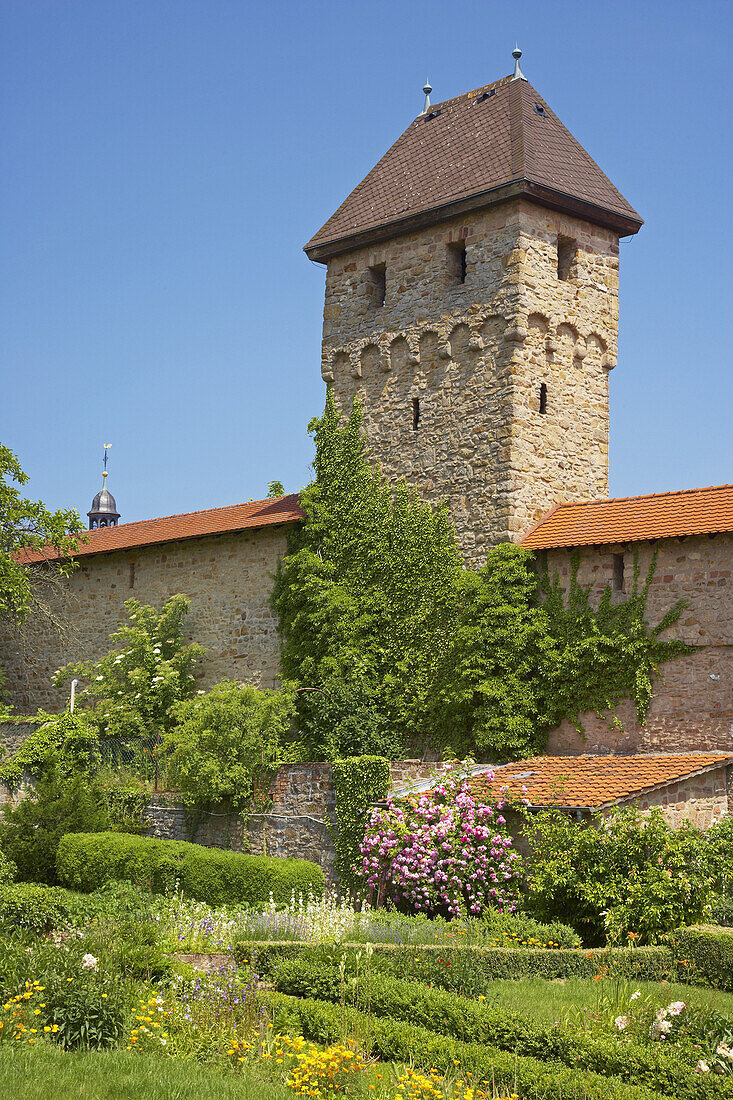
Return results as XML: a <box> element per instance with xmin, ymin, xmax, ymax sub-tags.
<box><xmin>270</xmin><ymin>959</ymin><xmax>721</xmax><ymax>1100</ymax></box>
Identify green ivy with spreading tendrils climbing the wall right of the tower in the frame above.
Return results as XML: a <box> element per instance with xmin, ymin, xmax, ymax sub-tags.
<box><xmin>541</xmin><ymin>553</ymin><xmax>690</xmax><ymax>732</ymax></box>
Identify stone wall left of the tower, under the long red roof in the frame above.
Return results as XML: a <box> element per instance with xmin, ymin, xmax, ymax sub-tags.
<box><xmin>0</xmin><ymin>527</ymin><xmax>285</xmax><ymax>713</ymax></box>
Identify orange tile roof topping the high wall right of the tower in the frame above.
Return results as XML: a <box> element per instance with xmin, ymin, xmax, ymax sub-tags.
<box><xmin>522</xmin><ymin>485</ymin><xmax>733</xmax><ymax>550</ymax></box>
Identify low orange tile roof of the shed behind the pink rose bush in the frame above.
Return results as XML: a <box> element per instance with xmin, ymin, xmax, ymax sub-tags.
<box><xmin>471</xmin><ymin>752</ymin><xmax>733</xmax><ymax>810</ymax></box>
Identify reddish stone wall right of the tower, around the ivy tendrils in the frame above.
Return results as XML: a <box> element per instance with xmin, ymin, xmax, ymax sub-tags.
<box><xmin>547</xmin><ymin>534</ymin><xmax>733</xmax><ymax>756</ymax></box>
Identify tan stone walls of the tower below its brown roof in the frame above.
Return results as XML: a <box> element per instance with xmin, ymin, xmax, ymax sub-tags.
<box><xmin>322</xmin><ymin>202</ymin><xmax>619</xmax><ymax>562</ymax></box>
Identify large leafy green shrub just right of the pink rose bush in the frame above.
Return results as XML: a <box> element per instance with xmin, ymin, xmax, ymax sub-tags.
<box><xmin>525</xmin><ymin>792</ymin><xmax>711</xmax><ymax>943</ymax></box>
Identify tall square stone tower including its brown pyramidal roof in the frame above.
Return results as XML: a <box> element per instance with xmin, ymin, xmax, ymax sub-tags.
<box><xmin>305</xmin><ymin>51</ymin><xmax>642</xmax><ymax>563</ymax></box>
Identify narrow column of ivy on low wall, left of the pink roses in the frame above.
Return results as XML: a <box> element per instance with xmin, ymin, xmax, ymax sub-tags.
<box><xmin>333</xmin><ymin>756</ymin><xmax>390</xmax><ymax>887</ymax></box>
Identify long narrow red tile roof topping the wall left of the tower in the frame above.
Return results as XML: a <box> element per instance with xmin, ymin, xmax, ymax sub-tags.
<box><xmin>21</xmin><ymin>493</ymin><xmax>303</xmax><ymax>563</ymax></box>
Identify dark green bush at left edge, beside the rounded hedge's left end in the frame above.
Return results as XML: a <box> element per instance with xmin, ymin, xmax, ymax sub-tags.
<box><xmin>0</xmin><ymin>767</ymin><xmax>109</xmax><ymax>886</ymax></box>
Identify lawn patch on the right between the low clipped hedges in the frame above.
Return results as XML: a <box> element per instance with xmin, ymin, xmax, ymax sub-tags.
<box><xmin>484</xmin><ymin>978</ymin><xmax>733</xmax><ymax>1024</ymax></box>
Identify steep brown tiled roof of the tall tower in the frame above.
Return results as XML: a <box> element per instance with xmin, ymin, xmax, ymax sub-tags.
<box><xmin>305</xmin><ymin>77</ymin><xmax>642</xmax><ymax>260</ymax></box>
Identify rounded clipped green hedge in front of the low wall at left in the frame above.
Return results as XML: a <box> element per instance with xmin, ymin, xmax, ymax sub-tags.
<box><xmin>56</xmin><ymin>833</ymin><xmax>325</xmax><ymax>905</ymax></box>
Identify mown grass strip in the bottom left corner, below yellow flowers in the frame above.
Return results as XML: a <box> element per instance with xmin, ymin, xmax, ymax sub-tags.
<box><xmin>0</xmin><ymin>1044</ymin><xmax>293</xmax><ymax>1100</ymax></box>
